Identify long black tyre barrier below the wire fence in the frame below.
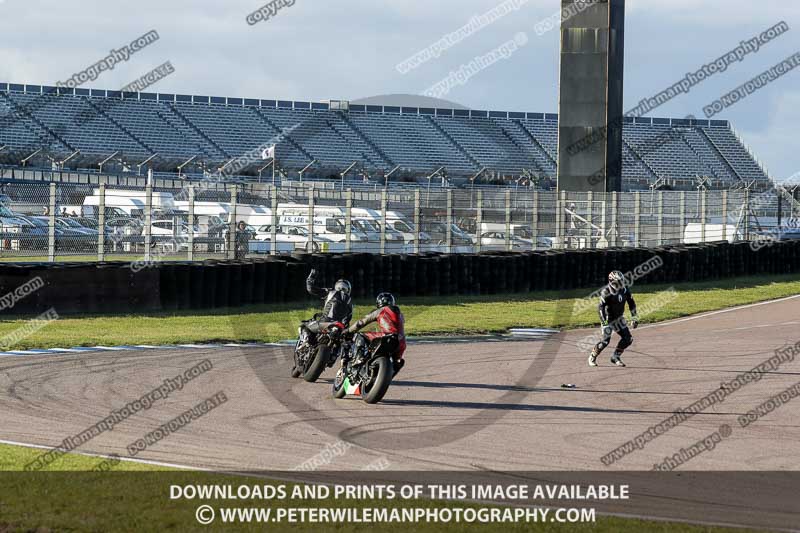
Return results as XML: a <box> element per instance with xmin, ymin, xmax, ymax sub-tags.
<box><xmin>0</xmin><ymin>241</ymin><xmax>800</xmax><ymax>315</ymax></box>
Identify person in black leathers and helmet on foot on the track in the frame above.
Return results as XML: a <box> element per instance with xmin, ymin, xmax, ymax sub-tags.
<box><xmin>589</xmin><ymin>270</ymin><xmax>639</xmax><ymax>367</ymax></box>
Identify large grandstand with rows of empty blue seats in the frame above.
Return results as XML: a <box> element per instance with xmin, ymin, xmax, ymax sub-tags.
<box><xmin>0</xmin><ymin>83</ymin><xmax>769</xmax><ymax>190</ymax></box>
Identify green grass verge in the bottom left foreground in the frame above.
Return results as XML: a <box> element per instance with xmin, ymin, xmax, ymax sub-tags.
<box><xmin>0</xmin><ymin>445</ymin><xmax>764</xmax><ymax>533</ymax></box>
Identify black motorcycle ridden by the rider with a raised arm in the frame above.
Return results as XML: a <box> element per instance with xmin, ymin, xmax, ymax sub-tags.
<box><xmin>292</xmin><ymin>321</ymin><xmax>348</xmax><ymax>383</ymax></box>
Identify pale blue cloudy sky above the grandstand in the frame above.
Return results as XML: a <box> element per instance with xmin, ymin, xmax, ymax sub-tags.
<box><xmin>0</xmin><ymin>0</ymin><xmax>800</xmax><ymax>180</ymax></box>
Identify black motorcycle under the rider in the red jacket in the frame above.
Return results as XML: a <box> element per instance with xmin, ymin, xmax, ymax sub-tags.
<box><xmin>333</xmin><ymin>333</ymin><xmax>399</xmax><ymax>403</ymax></box>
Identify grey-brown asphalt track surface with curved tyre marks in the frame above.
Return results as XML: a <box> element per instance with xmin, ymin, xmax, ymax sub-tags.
<box><xmin>0</xmin><ymin>298</ymin><xmax>800</xmax><ymax>524</ymax></box>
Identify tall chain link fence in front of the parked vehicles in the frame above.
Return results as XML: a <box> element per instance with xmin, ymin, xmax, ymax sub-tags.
<box><xmin>0</xmin><ymin>182</ymin><xmax>800</xmax><ymax>263</ymax></box>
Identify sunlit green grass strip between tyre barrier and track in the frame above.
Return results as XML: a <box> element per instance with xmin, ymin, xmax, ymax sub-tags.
<box><xmin>0</xmin><ymin>275</ymin><xmax>800</xmax><ymax>350</ymax></box>
